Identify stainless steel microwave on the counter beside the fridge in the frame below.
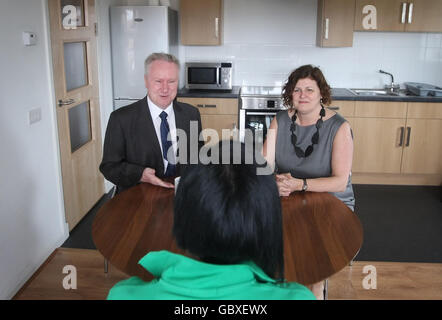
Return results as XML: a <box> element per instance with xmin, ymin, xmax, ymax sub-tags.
<box><xmin>185</xmin><ymin>62</ymin><xmax>232</xmax><ymax>90</ymax></box>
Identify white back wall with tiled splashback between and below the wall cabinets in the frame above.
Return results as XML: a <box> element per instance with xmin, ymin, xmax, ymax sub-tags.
<box><xmin>184</xmin><ymin>0</ymin><xmax>442</xmax><ymax>88</ymax></box>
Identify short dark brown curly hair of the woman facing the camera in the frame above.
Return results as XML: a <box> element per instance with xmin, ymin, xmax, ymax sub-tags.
<box><xmin>282</xmin><ymin>64</ymin><xmax>331</xmax><ymax>108</ymax></box>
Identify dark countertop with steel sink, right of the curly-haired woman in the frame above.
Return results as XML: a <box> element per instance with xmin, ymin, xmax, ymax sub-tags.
<box><xmin>332</xmin><ymin>88</ymin><xmax>442</xmax><ymax>102</ymax></box>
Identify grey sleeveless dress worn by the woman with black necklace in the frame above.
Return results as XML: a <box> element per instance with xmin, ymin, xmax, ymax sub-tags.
<box><xmin>275</xmin><ymin>111</ymin><xmax>355</xmax><ymax>211</ymax></box>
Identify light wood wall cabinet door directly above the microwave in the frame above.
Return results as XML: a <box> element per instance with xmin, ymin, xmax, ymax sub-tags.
<box><xmin>180</xmin><ymin>0</ymin><xmax>222</xmax><ymax>46</ymax></box>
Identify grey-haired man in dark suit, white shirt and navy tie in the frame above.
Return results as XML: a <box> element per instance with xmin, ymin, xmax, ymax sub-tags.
<box><xmin>100</xmin><ymin>53</ymin><xmax>201</xmax><ymax>192</ymax></box>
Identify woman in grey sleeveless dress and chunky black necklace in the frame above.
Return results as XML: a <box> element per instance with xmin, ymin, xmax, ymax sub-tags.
<box><xmin>263</xmin><ymin>65</ymin><xmax>355</xmax><ymax>298</ymax></box>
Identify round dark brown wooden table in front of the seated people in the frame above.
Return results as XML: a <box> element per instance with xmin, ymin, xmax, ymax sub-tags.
<box><xmin>92</xmin><ymin>183</ymin><xmax>363</xmax><ymax>285</ymax></box>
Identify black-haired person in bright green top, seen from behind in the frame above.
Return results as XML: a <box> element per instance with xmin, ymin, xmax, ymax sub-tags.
<box><xmin>107</xmin><ymin>141</ymin><xmax>315</xmax><ymax>300</ymax></box>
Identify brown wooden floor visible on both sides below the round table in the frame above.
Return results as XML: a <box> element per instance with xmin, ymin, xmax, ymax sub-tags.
<box><xmin>14</xmin><ymin>248</ymin><xmax>442</xmax><ymax>300</ymax></box>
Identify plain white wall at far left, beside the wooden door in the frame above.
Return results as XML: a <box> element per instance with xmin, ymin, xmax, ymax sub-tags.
<box><xmin>0</xmin><ymin>0</ymin><xmax>68</xmax><ymax>299</ymax></box>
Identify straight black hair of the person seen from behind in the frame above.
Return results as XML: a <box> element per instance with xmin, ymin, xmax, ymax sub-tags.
<box><xmin>173</xmin><ymin>141</ymin><xmax>284</xmax><ymax>281</ymax></box>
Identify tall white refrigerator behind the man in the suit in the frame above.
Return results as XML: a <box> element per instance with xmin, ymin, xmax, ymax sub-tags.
<box><xmin>110</xmin><ymin>6</ymin><xmax>178</xmax><ymax>110</ymax></box>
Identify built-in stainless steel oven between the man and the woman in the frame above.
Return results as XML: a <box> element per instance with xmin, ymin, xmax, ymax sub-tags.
<box><xmin>239</xmin><ymin>86</ymin><xmax>287</xmax><ymax>146</ymax></box>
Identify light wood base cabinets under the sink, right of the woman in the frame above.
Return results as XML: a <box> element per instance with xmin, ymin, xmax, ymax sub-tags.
<box><xmin>330</xmin><ymin>101</ymin><xmax>442</xmax><ymax>185</ymax></box>
